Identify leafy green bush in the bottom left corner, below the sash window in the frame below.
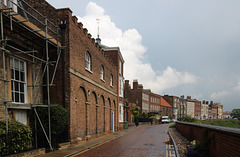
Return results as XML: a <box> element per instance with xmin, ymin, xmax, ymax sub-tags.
<box><xmin>0</xmin><ymin>121</ymin><xmax>32</xmax><ymax>156</ymax></box>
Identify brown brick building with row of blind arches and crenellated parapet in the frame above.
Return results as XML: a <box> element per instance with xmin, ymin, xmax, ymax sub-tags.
<box><xmin>24</xmin><ymin>0</ymin><xmax>123</xmax><ymax>142</ymax></box>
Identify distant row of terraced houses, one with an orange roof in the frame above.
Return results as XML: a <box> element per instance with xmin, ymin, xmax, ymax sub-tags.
<box><xmin>124</xmin><ymin>80</ymin><xmax>224</xmax><ymax>120</ymax></box>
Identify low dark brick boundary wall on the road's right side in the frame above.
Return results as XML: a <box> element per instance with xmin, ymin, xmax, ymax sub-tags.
<box><xmin>176</xmin><ymin>122</ymin><xmax>240</xmax><ymax>157</ymax></box>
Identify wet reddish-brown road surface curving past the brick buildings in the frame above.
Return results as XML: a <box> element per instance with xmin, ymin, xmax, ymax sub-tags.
<box><xmin>73</xmin><ymin>124</ymin><xmax>169</xmax><ymax>157</ymax></box>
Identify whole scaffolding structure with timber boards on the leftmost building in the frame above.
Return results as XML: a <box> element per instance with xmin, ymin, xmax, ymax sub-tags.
<box><xmin>0</xmin><ymin>0</ymin><xmax>62</xmax><ymax>150</ymax></box>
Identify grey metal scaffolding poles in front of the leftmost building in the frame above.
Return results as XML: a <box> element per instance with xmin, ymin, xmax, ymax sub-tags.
<box><xmin>0</xmin><ymin>0</ymin><xmax>62</xmax><ymax>151</ymax></box>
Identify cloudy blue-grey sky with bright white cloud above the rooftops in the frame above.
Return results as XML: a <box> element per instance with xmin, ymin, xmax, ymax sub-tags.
<box><xmin>47</xmin><ymin>0</ymin><xmax>240</xmax><ymax>111</ymax></box>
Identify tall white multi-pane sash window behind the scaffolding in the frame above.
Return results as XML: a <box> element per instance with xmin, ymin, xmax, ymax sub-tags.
<box><xmin>10</xmin><ymin>57</ymin><xmax>27</xmax><ymax>103</ymax></box>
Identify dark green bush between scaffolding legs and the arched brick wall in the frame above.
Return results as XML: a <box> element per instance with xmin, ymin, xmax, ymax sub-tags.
<box><xmin>30</xmin><ymin>105</ymin><xmax>69</xmax><ymax>149</ymax></box>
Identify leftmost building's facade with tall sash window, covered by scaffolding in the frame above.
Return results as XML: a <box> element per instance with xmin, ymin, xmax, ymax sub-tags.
<box><xmin>0</xmin><ymin>0</ymin><xmax>61</xmax><ymax>124</ymax></box>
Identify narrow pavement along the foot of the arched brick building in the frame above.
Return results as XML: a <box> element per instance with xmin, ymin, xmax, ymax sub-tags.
<box><xmin>39</xmin><ymin>126</ymin><xmax>140</xmax><ymax>157</ymax></box>
